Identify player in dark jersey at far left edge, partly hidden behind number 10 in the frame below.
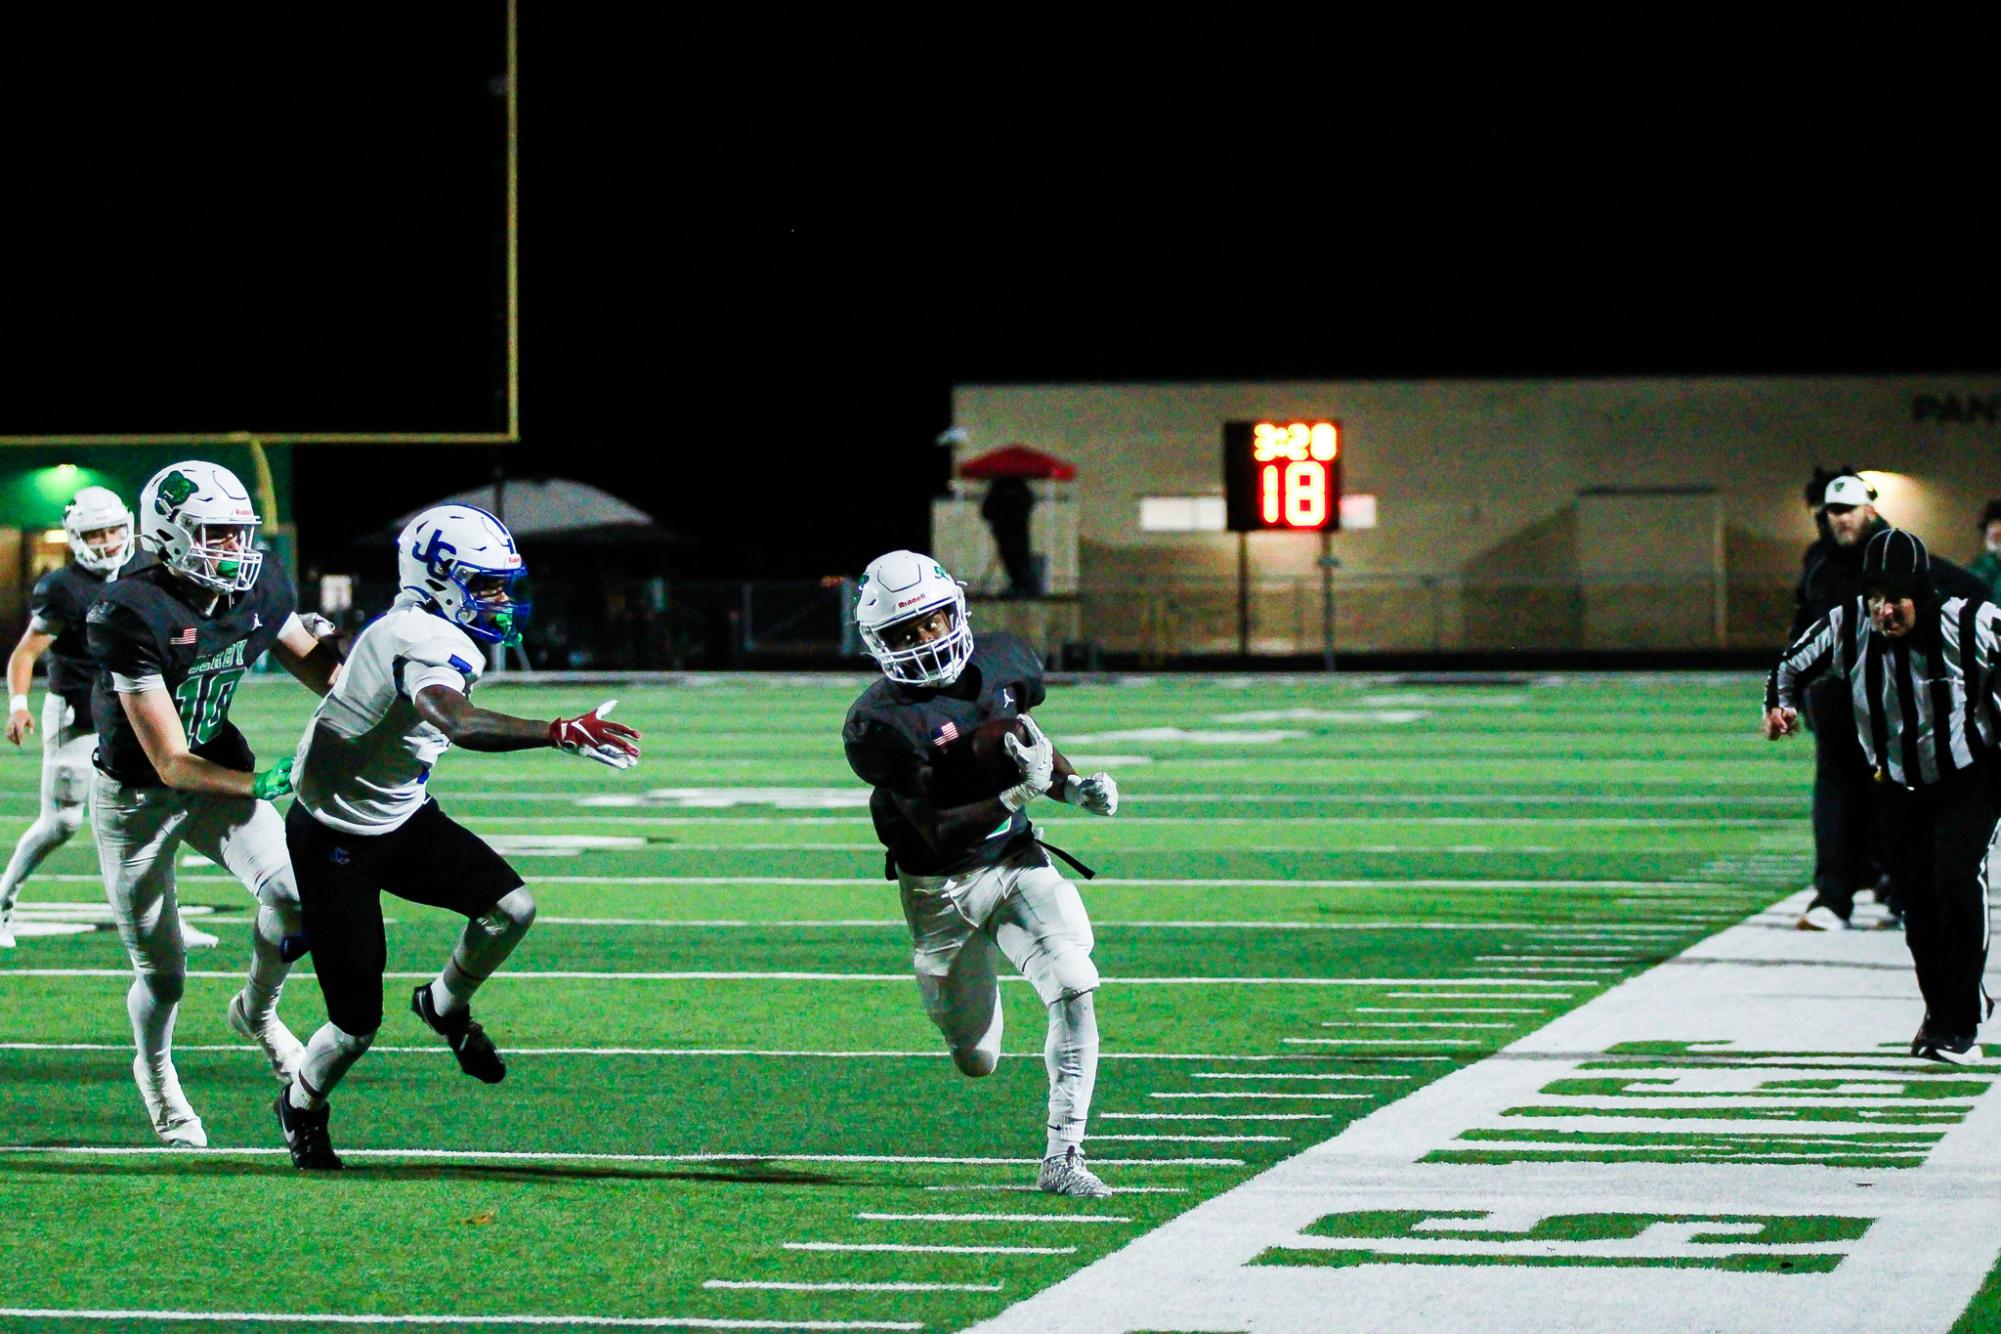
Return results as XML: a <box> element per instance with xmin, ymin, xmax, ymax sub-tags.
<box><xmin>0</xmin><ymin>486</ymin><xmax>216</xmax><ymax>950</ymax></box>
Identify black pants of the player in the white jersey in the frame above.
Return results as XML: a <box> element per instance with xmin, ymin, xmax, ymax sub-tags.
<box><xmin>284</xmin><ymin>802</ymin><xmax>522</xmax><ymax>1038</ymax></box>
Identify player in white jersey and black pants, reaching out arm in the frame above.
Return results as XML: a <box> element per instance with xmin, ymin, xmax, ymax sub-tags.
<box><xmin>274</xmin><ymin>504</ymin><xmax>640</xmax><ymax>1170</ymax></box>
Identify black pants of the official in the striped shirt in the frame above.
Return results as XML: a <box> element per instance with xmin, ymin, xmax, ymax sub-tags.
<box><xmin>1879</xmin><ymin>762</ymin><xmax>2001</xmax><ymax>1038</ymax></box>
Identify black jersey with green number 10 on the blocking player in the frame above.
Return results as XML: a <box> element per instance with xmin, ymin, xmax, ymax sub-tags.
<box><xmin>86</xmin><ymin>560</ymin><xmax>294</xmax><ymax>788</ymax></box>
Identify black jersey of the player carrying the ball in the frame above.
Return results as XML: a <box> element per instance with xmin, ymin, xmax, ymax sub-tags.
<box><xmin>840</xmin><ymin>630</ymin><xmax>1043</xmax><ymax>876</ymax></box>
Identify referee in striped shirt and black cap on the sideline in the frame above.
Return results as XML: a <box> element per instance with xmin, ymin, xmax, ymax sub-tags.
<box><xmin>1763</xmin><ymin>528</ymin><xmax>2001</xmax><ymax>1064</ymax></box>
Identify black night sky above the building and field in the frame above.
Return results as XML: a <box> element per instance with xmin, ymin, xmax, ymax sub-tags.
<box><xmin>0</xmin><ymin>0</ymin><xmax>2001</xmax><ymax>578</ymax></box>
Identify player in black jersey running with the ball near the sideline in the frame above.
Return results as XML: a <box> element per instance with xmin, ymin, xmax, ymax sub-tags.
<box><xmin>842</xmin><ymin>552</ymin><xmax>1119</xmax><ymax>1196</ymax></box>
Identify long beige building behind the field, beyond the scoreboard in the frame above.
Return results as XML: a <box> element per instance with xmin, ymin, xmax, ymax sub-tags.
<box><xmin>932</xmin><ymin>374</ymin><xmax>2001</xmax><ymax>660</ymax></box>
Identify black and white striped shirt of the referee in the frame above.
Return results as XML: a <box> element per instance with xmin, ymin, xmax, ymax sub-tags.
<box><xmin>1765</xmin><ymin>598</ymin><xmax>2001</xmax><ymax>788</ymax></box>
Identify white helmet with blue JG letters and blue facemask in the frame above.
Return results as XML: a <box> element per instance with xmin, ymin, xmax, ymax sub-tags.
<box><xmin>396</xmin><ymin>504</ymin><xmax>528</xmax><ymax>644</ymax></box>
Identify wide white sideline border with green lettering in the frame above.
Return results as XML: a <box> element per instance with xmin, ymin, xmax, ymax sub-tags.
<box><xmin>980</xmin><ymin>894</ymin><xmax>2001</xmax><ymax>1334</ymax></box>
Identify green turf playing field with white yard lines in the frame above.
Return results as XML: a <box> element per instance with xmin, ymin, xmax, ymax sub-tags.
<box><xmin>0</xmin><ymin>676</ymin><xmax>1995</xmax><ymax>1328</ymax></box>
